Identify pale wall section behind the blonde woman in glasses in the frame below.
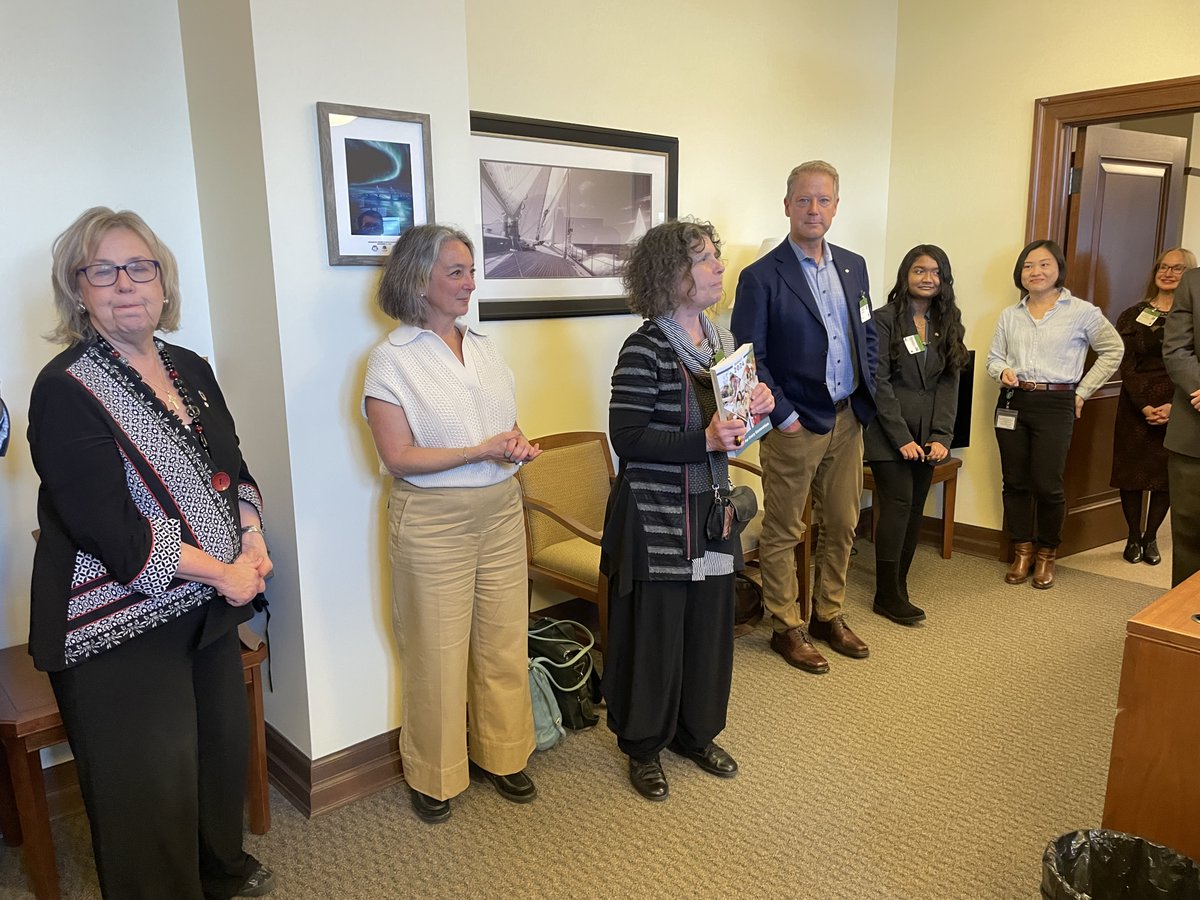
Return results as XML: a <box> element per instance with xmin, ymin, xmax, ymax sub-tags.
<box><xmin>0</xmin><ymin>0</ymin><xmax>212</xmax><ymax>647</ymax></box>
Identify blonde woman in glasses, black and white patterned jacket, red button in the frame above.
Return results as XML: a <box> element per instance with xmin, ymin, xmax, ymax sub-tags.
<box><xmin>29</xmin><ymin>206</ymin><xmax>275</xmax><ymax>900</ymax></box>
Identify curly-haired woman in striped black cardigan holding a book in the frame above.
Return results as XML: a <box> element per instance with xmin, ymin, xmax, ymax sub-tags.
<box><xmin>600</xmin><ymin>221</ymin><xmax>775</xmax><ymax>800</ymax></box>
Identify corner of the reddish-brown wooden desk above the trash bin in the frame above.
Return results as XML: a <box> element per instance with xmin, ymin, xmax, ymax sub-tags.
<box><xmin>1103</xmin><ymin>575</ymin><xmax>1200</xmax><ymax>859</ymax></box>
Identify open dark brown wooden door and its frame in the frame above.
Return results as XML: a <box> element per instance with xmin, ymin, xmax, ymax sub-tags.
<box><xmin>1026</xmin><ymin>77</ymin><xmax>1200</xmax><ymax>556</ymax></box>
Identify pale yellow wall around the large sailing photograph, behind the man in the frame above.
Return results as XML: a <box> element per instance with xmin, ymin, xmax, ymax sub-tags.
<box><xmin>467</xmin><ymin>0</ymin><xmax>896</xmax><ymax>605</ymax></box>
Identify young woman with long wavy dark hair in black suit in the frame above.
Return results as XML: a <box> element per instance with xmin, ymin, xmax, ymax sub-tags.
<box><xmin>863</xmin><ymin>244</ymin><xmax>968</xmax><ymax>625</ymax></box>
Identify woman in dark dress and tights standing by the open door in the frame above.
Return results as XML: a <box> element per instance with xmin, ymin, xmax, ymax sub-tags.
<box><xmin>1110</xmin><ymin>247</ymin><xmax>1196</xmax><ymax>565</ymax></box>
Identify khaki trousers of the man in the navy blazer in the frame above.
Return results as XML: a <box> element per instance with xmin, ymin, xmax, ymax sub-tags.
<box><xmin>758</xmin><ymin>407</ymin><xmax>863</xmax><ymax>631</ymax></box>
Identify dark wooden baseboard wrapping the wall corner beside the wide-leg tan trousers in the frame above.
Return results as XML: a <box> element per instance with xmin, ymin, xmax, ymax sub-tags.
<box><xmin>266</xmin><ymin>722</ymin><xmax>404</xmax><ymax>818</ymax></box>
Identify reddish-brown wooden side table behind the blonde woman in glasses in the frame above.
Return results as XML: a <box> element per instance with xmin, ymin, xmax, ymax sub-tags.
<box><xmin>0</xmin><ymin>644</ymin><xmax>271</xmax><ymax>900</ymax></box>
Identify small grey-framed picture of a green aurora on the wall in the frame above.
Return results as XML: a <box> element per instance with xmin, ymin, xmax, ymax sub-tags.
<box><xmin>317</xmin><ymin>103</ymin><xmax>433</xmax><ymax>265</ymax></box>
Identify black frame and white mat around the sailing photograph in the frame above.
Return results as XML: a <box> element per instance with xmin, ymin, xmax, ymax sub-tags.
<box><xmin>470</xmin><ymin>110</ymin><xmax>679</xmax><ymax>322</ymax></box>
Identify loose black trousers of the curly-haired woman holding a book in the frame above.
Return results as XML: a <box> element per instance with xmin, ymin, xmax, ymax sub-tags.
<box><xmin>602</xmin><ymin>575</ymin><xmax>734</xmax><ymax>760</ymax></box>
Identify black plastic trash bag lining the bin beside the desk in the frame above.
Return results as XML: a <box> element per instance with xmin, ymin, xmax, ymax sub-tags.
<box><xmin>1042</xmin><ymin>828</ymin><xmax>1200</xmax><ymax>900</ymax></box>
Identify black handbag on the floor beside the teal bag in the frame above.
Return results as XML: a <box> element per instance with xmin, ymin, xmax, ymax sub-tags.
<box><xmin>529</xmin><ymin>617</ymin><xmax>600</xmax><ymax>731</ymax></box>
